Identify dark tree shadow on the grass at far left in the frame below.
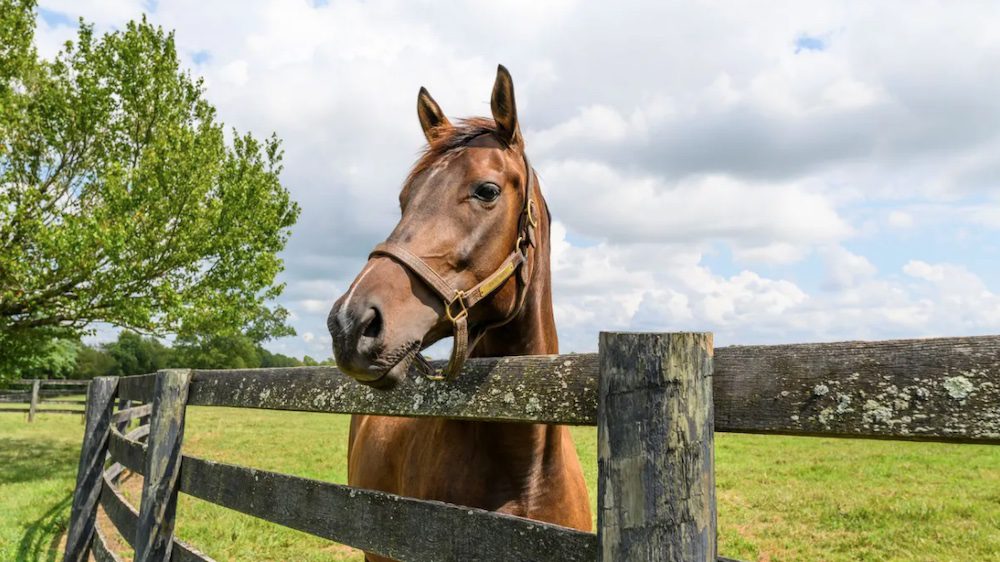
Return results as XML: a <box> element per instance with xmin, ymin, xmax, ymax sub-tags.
<box><xmin>0</xmin><ymin>437</ymin><xmax>80</xmax><ymax>484</ymax></box>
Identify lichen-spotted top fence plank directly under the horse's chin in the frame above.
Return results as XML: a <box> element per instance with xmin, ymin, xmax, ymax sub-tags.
<box><xmin>189</xmin><ymin>354</ymin><xmax>597</xmax><ymax>425</ymax></box>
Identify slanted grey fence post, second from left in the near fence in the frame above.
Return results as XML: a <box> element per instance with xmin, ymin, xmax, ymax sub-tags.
<box><xmin>134</xmin><ymin>369</ymin><xmax>191</xmax><ymax>562</ymax></box>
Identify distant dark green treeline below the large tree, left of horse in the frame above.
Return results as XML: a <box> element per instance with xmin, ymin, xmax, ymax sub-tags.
<box><xmin>11</xmin><ymin>331</ymin><xmax>333</xmax><ymax>379</ymax></box>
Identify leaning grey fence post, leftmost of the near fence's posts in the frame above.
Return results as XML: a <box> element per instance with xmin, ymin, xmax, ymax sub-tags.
<box><xmin>62</xmin><ymin>377</ymin><xmax>118</xmax><ymax>562</ymax></box>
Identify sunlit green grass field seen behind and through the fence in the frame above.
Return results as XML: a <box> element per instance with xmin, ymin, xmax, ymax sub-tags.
<box><xmin>0</xmin><ymin>407</ymin><xmax>1000</xmax><ymax>562</ymax></box>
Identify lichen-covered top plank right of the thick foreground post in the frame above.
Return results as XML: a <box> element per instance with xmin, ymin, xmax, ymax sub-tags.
<box><xmin>714</xmin><ymin>336</ymin><xmax>1000</xmax><ymax>443</ymax></box>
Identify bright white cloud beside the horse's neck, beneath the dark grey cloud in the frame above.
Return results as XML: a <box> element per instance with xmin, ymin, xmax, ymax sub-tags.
<box><xmin>543</xmin><ymin>164</ymin><xmax>851</xmax><ymax>247</ymax></box>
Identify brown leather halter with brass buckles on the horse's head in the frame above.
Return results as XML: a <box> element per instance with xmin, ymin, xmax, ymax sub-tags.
<box><xmin>368</xmin><ymin>151</ymin><xmax>538</xmax><ymax>380</ymax></box>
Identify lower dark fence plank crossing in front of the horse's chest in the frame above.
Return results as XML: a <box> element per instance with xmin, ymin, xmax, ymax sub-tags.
<box><xmin>181</xmin><ymin>457</ymin><xmax>597</xmax><ymax>562</ymax></box>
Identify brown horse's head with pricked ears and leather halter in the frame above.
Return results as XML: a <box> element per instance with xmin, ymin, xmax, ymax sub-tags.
<box><xmin>327</xmin><ymin>66</ymin><xmax>544</xmax><ymax>388</ymax></box>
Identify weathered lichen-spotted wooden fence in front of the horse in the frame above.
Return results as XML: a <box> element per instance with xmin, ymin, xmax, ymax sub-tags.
<box><xmin>65</xmin><ymin>333</ymin><xmax>1000</xmax><ymax>562</ymax></box>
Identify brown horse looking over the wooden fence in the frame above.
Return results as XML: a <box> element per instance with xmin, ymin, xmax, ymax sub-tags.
<box><xmin>327</xmin><ymin>65</ymin><xmax>591</xmax><ymax>562</ymax></box>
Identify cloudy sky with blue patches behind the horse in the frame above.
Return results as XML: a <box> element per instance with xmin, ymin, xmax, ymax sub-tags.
<box><xmin>37</xmin><ymin>0</ymin><xmax>1000</xmax><ymax>357</ymax></box>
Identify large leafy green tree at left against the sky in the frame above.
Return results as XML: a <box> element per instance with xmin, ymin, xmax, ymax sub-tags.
<box><xmin>0</xmin><ymin>0</ymin><xmax>299</xmax><ymax>376</ymax></box>
